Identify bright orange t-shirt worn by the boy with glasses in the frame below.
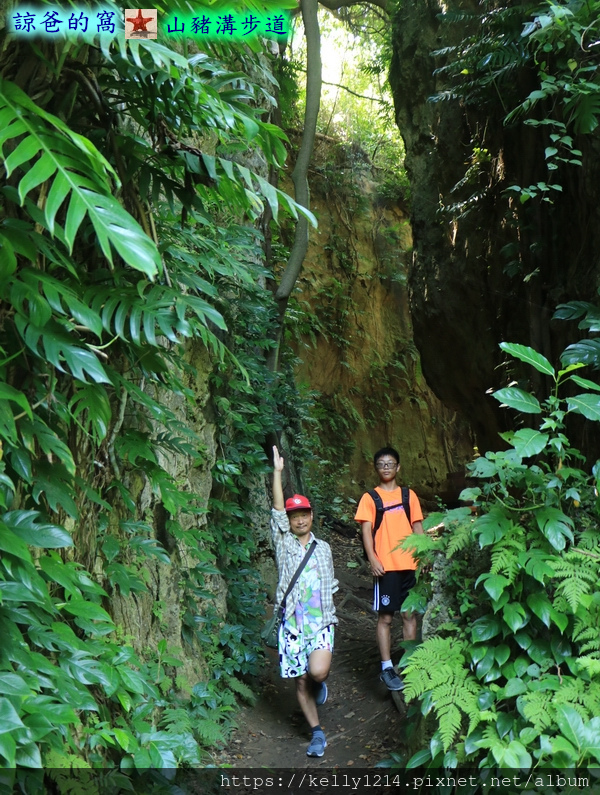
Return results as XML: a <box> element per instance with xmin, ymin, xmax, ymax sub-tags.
<box><xmin>354</xmin><ymin>486</ymin><xmax>423</xmax><ymax>571</ymax></box>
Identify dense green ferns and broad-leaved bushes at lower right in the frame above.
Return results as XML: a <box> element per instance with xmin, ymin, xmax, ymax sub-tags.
<box><xmin>403</xmin><ymin>342</ymin><xmax>600</xmax><ymax>769</ymax></box>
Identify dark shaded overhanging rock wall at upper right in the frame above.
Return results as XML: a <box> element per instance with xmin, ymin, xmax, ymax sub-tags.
<box><xmin>390</xmin><ymin>0</ymin><xmax>600</xmax><ymax>450</ymax></box>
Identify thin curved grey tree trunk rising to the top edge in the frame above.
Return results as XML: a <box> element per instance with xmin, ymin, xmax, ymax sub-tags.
<box><xmin>268</xmin><ymin>0</ymin><xmax>321</xmax><ymax>371</ymax></box>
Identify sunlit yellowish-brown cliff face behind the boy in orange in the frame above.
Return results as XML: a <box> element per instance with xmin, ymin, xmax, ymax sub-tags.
<box><xmin>288</xmin><ymin>140</ymin><xmax>473</xmax><ymax>499</ymax></box>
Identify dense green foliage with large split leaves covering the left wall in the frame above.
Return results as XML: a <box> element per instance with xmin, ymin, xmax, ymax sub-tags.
<box><xmin>0</xmin><ymin>4</ymin><xmax>310</xmax><ymax>768</ymax></box>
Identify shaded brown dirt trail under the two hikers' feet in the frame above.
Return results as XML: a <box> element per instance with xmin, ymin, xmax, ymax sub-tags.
<box><xmin>219</xmin><ymin>533</ymin><xmax>405</xmax><ymax>768</ymax></box>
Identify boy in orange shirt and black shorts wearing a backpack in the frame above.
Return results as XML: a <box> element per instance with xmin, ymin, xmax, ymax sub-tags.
<box><xmin>354</xmin><ymin>447</ymin><xmax>423</xmax><ymax>690</ymax></box>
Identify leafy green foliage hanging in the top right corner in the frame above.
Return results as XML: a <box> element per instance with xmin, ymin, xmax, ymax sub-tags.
<box><xmin>431</xmin><ymin>0</ymin><xmax>600</xmax><ymax>211</ymax></box>
